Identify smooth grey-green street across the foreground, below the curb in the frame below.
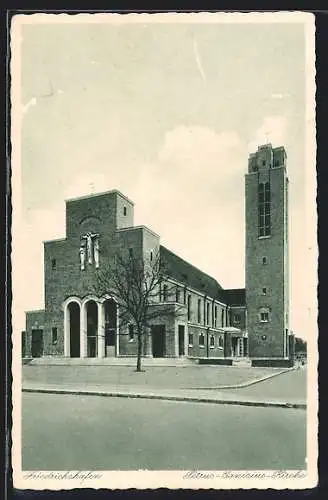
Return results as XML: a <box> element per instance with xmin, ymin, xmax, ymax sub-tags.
<box><xmin>22</xmin><ymin>393</ymin><xmax>306</xmax><ymax>470</ymax></box>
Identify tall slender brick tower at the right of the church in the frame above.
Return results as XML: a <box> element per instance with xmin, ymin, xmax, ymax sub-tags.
<box><xmin>245</xmin><ymin>144</ymin><xmax>289</xmax><ymax>358</ymax></box>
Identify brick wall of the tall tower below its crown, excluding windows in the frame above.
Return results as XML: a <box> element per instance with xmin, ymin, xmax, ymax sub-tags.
<box><xmin>245</xmin><ymin>146</ymin><xmax>288</xmax><ymax>357</ymax></box>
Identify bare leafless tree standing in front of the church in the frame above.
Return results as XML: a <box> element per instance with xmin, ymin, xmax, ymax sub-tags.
<box><xmin>95</xmin><ymin>251</ymin><xmax>184</xmax><ymax>372</ymax></box>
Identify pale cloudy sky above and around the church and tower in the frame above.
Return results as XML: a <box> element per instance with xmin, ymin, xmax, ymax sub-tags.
<box><xmin>14</xmin><ymin>16</ymin><xmax>314</xmax><ymax>337</ymax></box>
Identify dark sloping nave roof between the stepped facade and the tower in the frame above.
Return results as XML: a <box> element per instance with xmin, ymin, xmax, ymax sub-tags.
<box><xmin>160</xmin><ymin>245</ymin><xmax>224</xmax><ymax>300</ymax></box>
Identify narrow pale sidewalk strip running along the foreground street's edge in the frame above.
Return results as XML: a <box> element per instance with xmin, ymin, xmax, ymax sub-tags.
<box><xmin>22</xmin><ymin>381</ymin><xmax>306</xmax><ymax>410</ymax></box>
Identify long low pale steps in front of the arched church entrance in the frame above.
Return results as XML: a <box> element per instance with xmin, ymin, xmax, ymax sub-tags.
<box><xmin>23</xmin><ymin>356</ymin><xmax>197</xmax><ymax>366</ymax></box>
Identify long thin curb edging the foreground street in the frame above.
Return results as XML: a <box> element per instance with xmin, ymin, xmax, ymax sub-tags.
<box><xmin>22</xmin><ymin>388</ymin><xmax>307</xmax><ymax>410</ymax></box>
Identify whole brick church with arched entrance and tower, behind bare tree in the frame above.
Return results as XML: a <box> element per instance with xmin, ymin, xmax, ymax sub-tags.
<box><xmin>22</xmin><ymin>144</ymin><xmax>290</xmax><ymax>362</ymax></box>
